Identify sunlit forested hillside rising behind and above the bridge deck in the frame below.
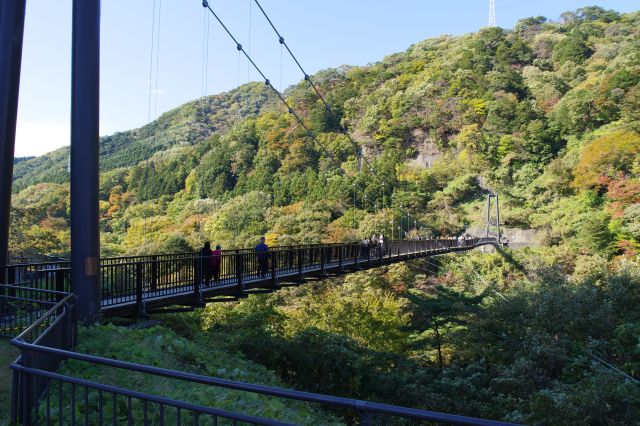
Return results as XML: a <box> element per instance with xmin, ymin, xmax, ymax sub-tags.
<box><xmin>12</xmin><ymin>7</ymin><xmax>640</xmax><ymax>256</ymax></box>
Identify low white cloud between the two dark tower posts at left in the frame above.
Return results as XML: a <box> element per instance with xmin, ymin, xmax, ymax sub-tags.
<box><xmin>15</xmin><ymin>120</ymin><xmax>71</xmax><ymax>157</ymax></box>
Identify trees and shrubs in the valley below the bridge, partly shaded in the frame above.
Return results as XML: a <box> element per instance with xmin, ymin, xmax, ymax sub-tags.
<box><xmin>161</xmin><ymin>252</ymin><xmax>640</xmax><ymax>425</ymax></box>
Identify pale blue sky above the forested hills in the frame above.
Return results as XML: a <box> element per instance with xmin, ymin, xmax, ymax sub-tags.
<box><xmin>15</xmin><ymin>0</ymin><xmax>639</xmax><ymax>157</ymax></box>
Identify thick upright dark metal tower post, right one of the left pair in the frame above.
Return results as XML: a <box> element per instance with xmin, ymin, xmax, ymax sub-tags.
<box><xmin>71</xmin><ymin>0</ymin><xmax>100</xmax><ymax>320</ymax></box>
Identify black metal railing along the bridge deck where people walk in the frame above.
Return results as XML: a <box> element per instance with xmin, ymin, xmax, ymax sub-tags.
<box><xmin>5</xmin><ymin>238</ymin><xmax>494</xmax><ymax>313</ymax></box>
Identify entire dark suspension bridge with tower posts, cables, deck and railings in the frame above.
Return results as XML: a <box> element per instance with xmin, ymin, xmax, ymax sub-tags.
<box><xmin>0</xmin><ymin>0</ymin><xmax>510</xmax><ymax>425</ymax></box>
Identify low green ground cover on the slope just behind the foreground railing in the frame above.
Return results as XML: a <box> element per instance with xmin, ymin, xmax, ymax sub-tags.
<box><xmin>45</xmin><ymin>325</ymin><xmax>342</xmax><ymax>425</ymax></box>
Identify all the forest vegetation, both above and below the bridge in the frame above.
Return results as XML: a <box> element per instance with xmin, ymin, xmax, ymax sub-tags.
<box><xmin>10</xmin><ymin>7</ymin><xmax>640</xmax><ymax>424</ymax></box>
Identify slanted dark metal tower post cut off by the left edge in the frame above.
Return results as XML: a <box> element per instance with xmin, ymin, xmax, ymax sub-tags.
<box><xmin>0</xmin><ymin>0</ymin><xmax>26</xmax><ymax>282</ymax></box>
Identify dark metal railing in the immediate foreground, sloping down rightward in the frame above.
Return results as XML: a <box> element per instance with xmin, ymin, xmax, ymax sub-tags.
<box><xmin>11</xmin><ymin>340</ymin><xmax>506</xmax><ymax>425</ymax></box>
